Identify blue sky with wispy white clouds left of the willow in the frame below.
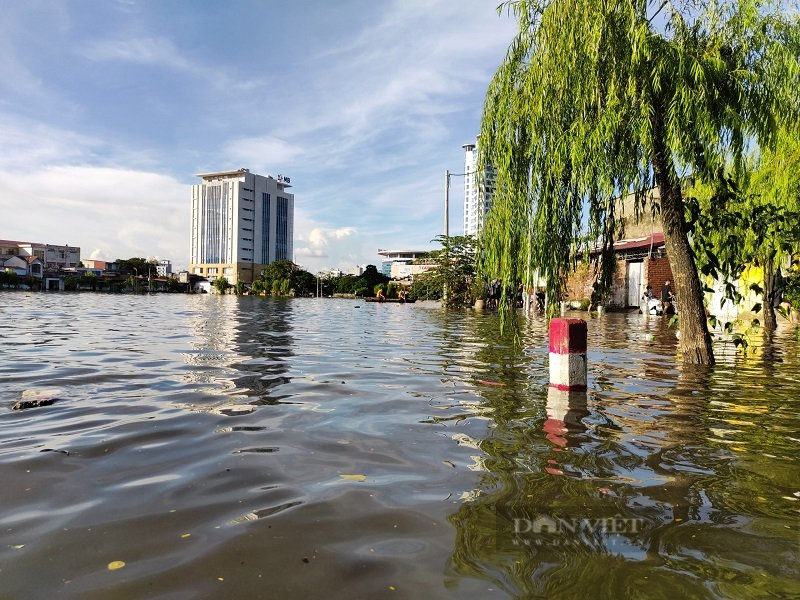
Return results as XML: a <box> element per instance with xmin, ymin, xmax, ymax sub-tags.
<box><xmin>0</xmin><ymin>0</ymin><xmax>514</xmax><ymax>271</ymax></box>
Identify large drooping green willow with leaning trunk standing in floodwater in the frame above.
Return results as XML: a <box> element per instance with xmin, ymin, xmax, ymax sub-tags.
<box><xmin>479</xmin><ymin>0</ymin><xmax>800</xmax><ymax>363</ymax></box>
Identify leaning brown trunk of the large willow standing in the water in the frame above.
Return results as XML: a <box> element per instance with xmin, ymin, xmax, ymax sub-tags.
<box><xmin>652</xmin><ymin>115</ymin><xmax>714</xmax><ymax>365</ymax></box>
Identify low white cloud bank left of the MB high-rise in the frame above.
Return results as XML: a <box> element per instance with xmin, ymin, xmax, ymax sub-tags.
<box><xmin>0</xmin><ymin>166</ymin><xmax>189</xmax><ymax>266</ymax></box>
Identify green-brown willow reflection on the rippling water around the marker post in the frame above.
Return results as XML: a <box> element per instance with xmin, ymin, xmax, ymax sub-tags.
<box><xmin>448</xmin><ymin>315</ymin><xmax>797</xmax><ymax>598</ymax></box>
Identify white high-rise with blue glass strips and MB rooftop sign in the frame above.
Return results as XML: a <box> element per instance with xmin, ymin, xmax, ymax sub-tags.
<box><xmin>189</xmin><ymin>169</ymin><xmax>294</xmax><ymax>284</ymax></box>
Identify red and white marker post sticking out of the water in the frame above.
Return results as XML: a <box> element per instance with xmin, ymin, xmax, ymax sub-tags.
<box><xmin>550</xmin><ymin>319</ymin><xmax>586</xmax><ymax>392</ymax></box>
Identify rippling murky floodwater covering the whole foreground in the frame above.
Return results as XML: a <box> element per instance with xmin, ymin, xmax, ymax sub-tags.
<box><xmin>0</xmin><ymin>292</ymin><xmax>800</xmax><ymax>600</ymax></box>
